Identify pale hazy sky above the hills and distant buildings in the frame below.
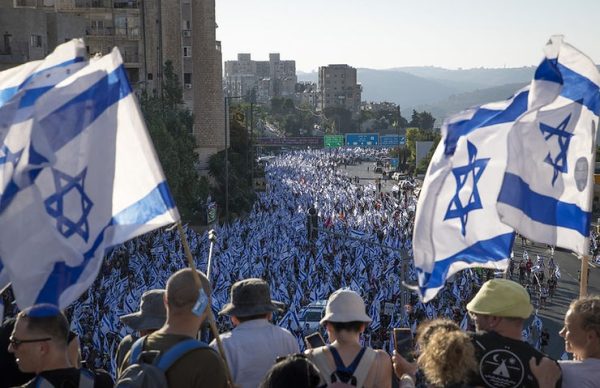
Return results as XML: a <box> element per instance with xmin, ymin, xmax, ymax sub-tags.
<box><xmin>216</xmin><ymin>0</ymin><xmax>600</xmax><ymax>71</ymax></box>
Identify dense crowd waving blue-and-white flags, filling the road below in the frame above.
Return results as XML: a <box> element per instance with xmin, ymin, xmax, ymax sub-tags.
<box><xmin>5</xmin><ymin>149</ymin><xmax>592</xmax><ymax>388</ymax></box>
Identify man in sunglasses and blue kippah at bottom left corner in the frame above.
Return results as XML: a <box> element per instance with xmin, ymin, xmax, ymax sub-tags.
<box><xmin>8</xmin><ymin>304</ymin><xmax>113</xmax><ymax>388</ymax></box>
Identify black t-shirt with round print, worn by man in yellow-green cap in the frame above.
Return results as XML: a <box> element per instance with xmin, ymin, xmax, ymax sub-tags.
<box><xmin>469</xmin><ymin>332</ymin><xmax>561</xmax><ymax>388</ymax></box>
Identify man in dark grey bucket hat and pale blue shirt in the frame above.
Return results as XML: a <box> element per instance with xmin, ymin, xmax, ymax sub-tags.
<box><xmin>210</xmin><ymin>279</ymin><xmax>300</xmax><ymax>388</ymax></box>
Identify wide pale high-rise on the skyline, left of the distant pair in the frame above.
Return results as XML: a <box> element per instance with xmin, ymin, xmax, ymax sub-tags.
<box><xmin>225</xmin><ymin>53</ymin><xmax>298</xmax><ymax>104</ymax></box>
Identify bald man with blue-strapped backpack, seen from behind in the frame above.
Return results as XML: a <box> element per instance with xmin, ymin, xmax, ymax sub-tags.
<box><xmin>116</xmin><ymin>268</ymin><xmax>228</xmax><ymax>388</ymax></box>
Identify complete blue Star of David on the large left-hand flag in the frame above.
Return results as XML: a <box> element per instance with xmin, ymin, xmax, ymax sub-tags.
<box><xmin>44</xmin><ymin>168</ymin><xmax>94</xmax><ymax>242</ymax></box>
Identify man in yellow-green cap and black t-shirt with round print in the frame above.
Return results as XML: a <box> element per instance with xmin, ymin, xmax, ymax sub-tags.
<box><xmin>467</xmin><ymin>279</ymin><xmax>560</xmax><ymax>388</ymax></box>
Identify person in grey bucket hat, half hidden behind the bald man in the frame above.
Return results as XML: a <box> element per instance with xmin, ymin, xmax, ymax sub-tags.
<box><xmin>117</xmin><ymin>290</ymin><xmax>167</xmax><ymax>372</ymax></box>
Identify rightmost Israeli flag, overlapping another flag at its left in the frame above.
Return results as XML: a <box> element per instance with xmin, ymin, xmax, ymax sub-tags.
<box><xmin>498</xmin><ymin>37</ymin><xmax>600</xmax><ymax>254</ymax></box>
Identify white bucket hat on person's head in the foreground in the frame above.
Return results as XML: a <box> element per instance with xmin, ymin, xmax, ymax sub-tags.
<box><xmin>321</xmin><ymin>289</ymin><xmax>371</xmax><ymax>325</ymax></box>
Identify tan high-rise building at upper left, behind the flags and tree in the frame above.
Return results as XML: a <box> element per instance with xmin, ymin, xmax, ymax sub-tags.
<box><xmin>0</xmin><ymin>0</ymin><xmax>225</xmax><ymax>168</ymax></box>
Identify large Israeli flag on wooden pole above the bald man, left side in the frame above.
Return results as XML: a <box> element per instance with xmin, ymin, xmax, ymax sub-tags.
<box><xmin>0</xmin><ymin>45</ymin><xmax>179</xmax><ymax>309</ymax></box>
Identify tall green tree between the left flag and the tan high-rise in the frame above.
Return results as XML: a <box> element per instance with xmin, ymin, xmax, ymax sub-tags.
<box><xmin>141</xmin><ymin>61</ymin><xmax>209</xmax><ymax>222</ymax></box>
